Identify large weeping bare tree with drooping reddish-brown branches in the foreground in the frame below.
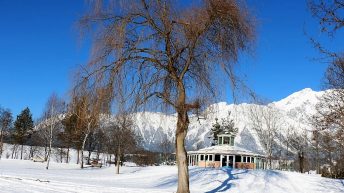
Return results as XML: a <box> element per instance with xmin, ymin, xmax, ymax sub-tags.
<box><xmin>80</xmin><ymin>0</ymin><xmax>254</xmax><ymax>192</ymax></box>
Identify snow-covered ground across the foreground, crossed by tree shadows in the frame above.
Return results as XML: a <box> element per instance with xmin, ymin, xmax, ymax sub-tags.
<box><xmin>0</xmin><ymin>159</ymin><xmax>344</xmax><ymax>193</ymax></box>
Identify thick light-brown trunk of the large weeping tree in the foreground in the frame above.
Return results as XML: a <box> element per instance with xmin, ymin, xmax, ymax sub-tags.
<box><xmin>176</xmin><ymin>111</ymin><xmax>190</xmax><ymax>193</ymax></box>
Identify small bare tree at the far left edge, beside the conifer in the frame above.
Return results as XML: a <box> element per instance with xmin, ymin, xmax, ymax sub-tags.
<box><xmin>0</xmin><ymin>107</ymin><xmax>13</xmax><ymax>159</ymax></box>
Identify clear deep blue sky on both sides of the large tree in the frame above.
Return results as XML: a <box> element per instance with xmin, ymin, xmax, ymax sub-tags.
<box><xmin>0</xmin><ymin>0</ymin><xmax>339</xmax><ymax>118</ymax></box>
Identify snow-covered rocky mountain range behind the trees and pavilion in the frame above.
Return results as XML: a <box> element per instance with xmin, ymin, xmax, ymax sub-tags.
<box><xmin>103</xmin><ymin>88</ymin><xmax>324</xmax><ymax>152</ymax></box>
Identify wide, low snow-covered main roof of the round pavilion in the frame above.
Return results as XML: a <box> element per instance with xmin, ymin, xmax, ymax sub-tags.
<box><xmin>188</xmin><ymin>145</ymin><xmax>266</xmax><ymax>157</ymax></box>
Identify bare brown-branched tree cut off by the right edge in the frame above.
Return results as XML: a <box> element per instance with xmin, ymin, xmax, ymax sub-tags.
<box><xmin>308</xmin><ymin>0</ymin><xmax>344</xmax><ymax>177</ymax></box>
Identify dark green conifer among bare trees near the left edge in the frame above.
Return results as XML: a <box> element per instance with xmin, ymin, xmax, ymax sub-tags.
<box><xmin>14</xmin><ymin>107</ymin><xmax>33</xmax><ymax>159</ymax></box>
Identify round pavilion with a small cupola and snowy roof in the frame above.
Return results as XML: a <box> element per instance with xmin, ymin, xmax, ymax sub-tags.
<box><xmin>187</xmin><ymin>116</ymin><xmax>267</xmax><ymax>169</ymax></box>
